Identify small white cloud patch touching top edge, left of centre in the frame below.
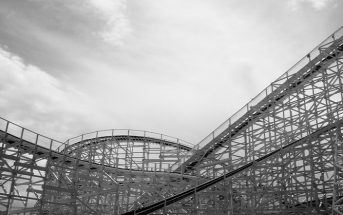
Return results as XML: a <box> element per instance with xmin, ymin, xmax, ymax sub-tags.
<box><xmin>88</xmin><ymin>0</ymin><xmax>132</xmax><ymax>45</ymax></box>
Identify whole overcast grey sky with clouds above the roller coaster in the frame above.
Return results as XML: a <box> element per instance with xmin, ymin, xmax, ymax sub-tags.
<box><xmin>0</xmin><ymin>0</ymin><xmax>343</xmax><ymax>143</ymax></box>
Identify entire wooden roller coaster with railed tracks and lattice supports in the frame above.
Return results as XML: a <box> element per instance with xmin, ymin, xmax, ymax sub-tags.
<box><xmin>0</xmin><ymin>27</ymin><xmax>343</xmax><ymax>215</ymax></box>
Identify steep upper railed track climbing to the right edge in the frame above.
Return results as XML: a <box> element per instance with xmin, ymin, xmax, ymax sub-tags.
<box><xmin>176</xmin><ymin>27</ymin><xmax>343</xmax><ymax>173</ymax></box>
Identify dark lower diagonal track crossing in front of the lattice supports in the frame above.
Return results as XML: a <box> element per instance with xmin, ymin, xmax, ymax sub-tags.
<box><xmin>123</xmin><ymin>120</ymin><xmax>343</xmax><ymax>215</ymax></box>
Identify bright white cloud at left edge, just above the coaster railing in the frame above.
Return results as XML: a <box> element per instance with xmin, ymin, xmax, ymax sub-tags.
<box><xmin>0</xmin><ymin>48</ymin><xmax>92</xmax><ymax>140</ymax></box>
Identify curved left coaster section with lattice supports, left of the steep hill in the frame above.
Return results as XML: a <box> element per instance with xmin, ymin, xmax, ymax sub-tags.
<box><xmin>0</xmin><ymin>119</ymin><xmax>194</xmax><ymax>214</ymax></box>
